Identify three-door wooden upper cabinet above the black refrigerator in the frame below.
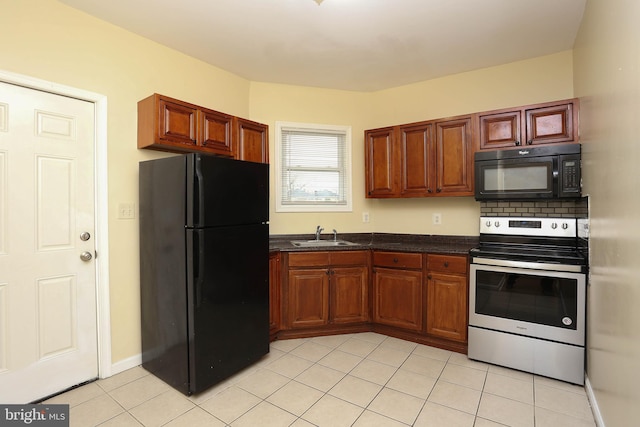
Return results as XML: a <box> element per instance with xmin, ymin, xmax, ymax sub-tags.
<box><xmin>138</xmin><ymin>93</ymin><xmax>269</xmax><ymax>163</ymax></box>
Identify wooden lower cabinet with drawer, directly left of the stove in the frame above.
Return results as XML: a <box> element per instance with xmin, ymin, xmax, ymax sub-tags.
<box><xmin>426</xmin><ymin>255</ymin><xmax>468</xmax><ymax>342</ymax></box>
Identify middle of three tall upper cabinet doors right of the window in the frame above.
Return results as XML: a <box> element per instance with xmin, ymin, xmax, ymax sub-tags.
<box><xmin>399</xmin><ymin>123</ymin><xmax>434</xmax><ymax>196</ymax></box>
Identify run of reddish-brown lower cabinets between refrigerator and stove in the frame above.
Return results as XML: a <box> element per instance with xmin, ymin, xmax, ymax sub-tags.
<box><xmin>271</xmin><ymin>250</ymin><xmax>468</xmax><ymax>353</ymax></box>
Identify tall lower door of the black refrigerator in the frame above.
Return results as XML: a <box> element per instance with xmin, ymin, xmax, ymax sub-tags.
<box><xmin>186</xmin><ymin>224</ymin><xmax>269</xmax><ymax>393</ymax></box>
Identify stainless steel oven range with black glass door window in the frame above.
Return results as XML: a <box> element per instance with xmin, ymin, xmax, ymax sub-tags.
<box><xmin>468</xmin><ymin>217</ymin><xmax>587</xmax><ymax>384</ymax></box>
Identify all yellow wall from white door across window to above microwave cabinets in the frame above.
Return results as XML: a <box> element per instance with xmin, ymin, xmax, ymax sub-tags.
<box><xmin>0</xmin><ymin>0</ymin><xmax>573</xmax><ymax>368</ymax></box>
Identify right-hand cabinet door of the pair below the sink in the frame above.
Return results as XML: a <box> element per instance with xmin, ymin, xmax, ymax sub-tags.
<box><xmin>329</xmin><ymin>267</ymin><xmax>369</xmax><ymax>323</ymax></box>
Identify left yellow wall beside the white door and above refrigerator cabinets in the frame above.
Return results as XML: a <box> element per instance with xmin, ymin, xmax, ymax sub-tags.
<box><xmin>0</xmin><ymin>0</ymin><xmax>255</xmax><ymax>362</ymax></box>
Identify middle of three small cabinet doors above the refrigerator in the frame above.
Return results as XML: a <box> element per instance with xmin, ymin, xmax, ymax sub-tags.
<box><xmin>198</xmin><ymin>109</ymin><xmax>233</xmax><ymax>156</ymax></box>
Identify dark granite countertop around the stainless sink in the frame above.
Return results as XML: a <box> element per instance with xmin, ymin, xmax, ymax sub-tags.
<box><xmin>269</xmin><ymin>233</ymin><xmax>478</xmax><ymax>255</ymax></box>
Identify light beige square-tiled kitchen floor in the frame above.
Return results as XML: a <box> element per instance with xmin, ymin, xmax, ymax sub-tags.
<box><xmin>47</xmin><ymin>332</ymin><xmax>595</xmax><ymax>427</ymax></box>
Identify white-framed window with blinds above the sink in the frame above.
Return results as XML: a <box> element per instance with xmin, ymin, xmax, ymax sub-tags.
<box><xmin>276</xmin><ymin>122</ymin><xmax>351</xmax><ymax>212</ymax></box>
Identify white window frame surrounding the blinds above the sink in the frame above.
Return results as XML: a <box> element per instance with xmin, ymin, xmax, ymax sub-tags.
<box><xmin>275</xmin><ymin>121</ymin><xmax>353</xmax><ymax>212</ymax></box>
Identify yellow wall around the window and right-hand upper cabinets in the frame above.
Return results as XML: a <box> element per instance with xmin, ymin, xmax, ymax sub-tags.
<box><xmin>251</xmin><ymin>51</ymin><xmax>573</xmax><ymax>235</ymax></box>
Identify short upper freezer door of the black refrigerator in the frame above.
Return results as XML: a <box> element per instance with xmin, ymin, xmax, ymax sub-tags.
<box><xmin>186</xmin><ymin>154</ymin><xmax>269</xmax><ymax>228</ymax></box>
